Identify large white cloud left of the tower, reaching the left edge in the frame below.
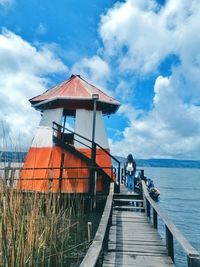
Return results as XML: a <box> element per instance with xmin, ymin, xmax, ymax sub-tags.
<box><xmin>0</xmin><ymin>30</ymin><xmax>67</xmax><ymax>149</ymax></box>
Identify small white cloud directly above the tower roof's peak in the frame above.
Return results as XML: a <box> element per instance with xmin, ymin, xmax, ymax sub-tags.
<box><xmin>71</xmin><ymin>56</ymin><xmax>110</xmax><ymax>89</ymax></box>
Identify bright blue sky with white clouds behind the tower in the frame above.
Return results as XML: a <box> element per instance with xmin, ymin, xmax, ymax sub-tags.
<box><xmin>0</xmin><ymin>0</ymin><xmax>200</xmax><ymax>160</ymax></box>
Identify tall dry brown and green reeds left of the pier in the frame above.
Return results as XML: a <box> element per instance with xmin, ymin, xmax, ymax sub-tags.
<box><xmin>0</xmin><ymin>185</ymin><xmax>89</xmax><ymax>267</ymax></box>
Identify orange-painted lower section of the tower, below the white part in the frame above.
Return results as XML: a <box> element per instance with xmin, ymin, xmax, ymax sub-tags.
<box><xmin>17</xmin><ymin>146</ymin><xmax>112</xmax><ymax>193</ymax></box>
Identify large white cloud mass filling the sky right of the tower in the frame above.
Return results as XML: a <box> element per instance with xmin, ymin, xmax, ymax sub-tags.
<box><xmin>99</xmin><ymin>0</ymin><xmax>200</xmax><ymax>159</ymax></box>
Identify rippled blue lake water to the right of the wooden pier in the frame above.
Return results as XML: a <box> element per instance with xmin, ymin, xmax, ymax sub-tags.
<box><xmin>142</xmin><ymin>167</ymin><xmax>200</xmax><ymax>267</ymax></box>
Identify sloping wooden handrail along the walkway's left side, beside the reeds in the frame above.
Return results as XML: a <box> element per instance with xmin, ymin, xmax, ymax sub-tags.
<box><xmin>80</xmin><ymin>183</ymin><xmax>114</xmax><ymax>267</ymax></box>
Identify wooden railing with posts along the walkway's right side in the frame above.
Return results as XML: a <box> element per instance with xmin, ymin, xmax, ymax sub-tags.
<box><xmin>142</xmin><ymin>181</ymin><xmax>200</xmax><ymax>267</ymax></box>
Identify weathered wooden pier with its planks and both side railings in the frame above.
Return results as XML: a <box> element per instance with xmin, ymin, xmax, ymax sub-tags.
<box><xmin>80</xmin><ymin>182</ymin><xmax>200</xmax><ymax>267</ymax></box>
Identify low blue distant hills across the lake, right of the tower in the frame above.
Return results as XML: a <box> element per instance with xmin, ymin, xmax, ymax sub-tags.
<box><xmin>116</xmin><ymin>156</ymin><xmax>200</xmax><ymax>168</ymax></box>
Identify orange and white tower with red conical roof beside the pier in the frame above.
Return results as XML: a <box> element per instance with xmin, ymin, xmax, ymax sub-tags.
<box><xmin>17</xmin><ymin>75</ymin><xmax>120</xmax><ymax>193</ymax></box>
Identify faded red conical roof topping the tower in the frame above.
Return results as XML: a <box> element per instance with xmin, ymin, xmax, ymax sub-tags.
<box><xmin>29</xmin><ymin>75</ymin><xmax>120</xmax><ymax>114</ymax></box>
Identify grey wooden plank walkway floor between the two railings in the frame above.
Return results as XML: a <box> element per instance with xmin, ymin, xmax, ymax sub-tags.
<box><xmin>103</xmin><ymin>186</ymin><xmax>174</xmax><ymax>267</ymax></box>
